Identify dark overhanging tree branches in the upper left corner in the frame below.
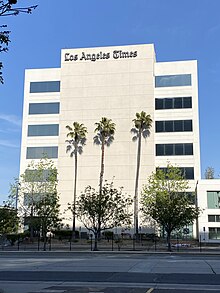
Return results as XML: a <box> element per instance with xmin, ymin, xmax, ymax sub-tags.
<box><xmin>0</xmin><ymin>0</ymin><xmax>37</xmax><ymax>83</ymax></box>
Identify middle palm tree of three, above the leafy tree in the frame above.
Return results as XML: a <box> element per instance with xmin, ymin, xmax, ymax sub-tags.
<box><xmin>93</xmin><ymin>117</ymin><xmax>115</xmax><ymax>195</ymax></box>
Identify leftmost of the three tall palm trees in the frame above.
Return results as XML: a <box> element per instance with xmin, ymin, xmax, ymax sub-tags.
<box><xmin>66</xmin><ymin>122</ymin><xmax>87</xmax><ymax>239</ymax></box>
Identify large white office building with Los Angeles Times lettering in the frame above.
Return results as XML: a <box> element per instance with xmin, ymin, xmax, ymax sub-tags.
<box><xmin>20</xmin><ymin>44</ymin><xmax>220</xmax><ymax>240</ymax></box>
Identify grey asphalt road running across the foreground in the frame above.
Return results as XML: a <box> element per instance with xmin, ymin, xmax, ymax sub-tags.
<box><xmin>0</xmin><ymin>252</ymin><xmax>220</xmax><ymax>293</ymax></box>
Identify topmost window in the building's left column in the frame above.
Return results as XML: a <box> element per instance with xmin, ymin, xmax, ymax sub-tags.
<box><xmin>30</xmin><ymin>81</ymin><xmax>60</xmax><ymax>93</ymax></box>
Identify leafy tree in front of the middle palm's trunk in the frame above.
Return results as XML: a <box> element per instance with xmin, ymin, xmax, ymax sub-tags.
<box><xmin>76</xmin><ymin>182</ymin><xmax>132</xmax><ymax>250</ymax></box>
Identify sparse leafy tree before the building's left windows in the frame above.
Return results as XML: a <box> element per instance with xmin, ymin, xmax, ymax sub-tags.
<box><xmin>18</xmin><ymin>158</ymin><xmax>60</xmax><ymax>249</ymax></box>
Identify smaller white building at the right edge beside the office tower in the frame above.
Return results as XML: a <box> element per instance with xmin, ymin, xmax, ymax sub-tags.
<box><xmin>196</xmin><ymin>179</ymin><xmax>220</xmax><ymax>243</ymax></box>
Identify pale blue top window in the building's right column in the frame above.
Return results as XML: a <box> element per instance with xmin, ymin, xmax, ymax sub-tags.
<box><xmin>155</xmin><ymin>74</ymin><xmax>191</xmax><ymax>87</ymax></box>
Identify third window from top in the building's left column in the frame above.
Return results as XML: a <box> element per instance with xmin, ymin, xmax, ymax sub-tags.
<box><xmin>28</xmin><ymin>124</ymin><xmax>59</xmax><ymax>136</ymax></box>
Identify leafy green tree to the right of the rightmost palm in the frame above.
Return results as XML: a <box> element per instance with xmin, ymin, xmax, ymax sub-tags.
<box><xmin>142</xmin><ymin>165</ymin><xmax>200</xmax><ymax>251</ymax></box>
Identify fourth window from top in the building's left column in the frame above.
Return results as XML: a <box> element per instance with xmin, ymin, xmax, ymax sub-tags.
<box><xmin>26</xmin><ymin>146</ymin><xmax>58</xmax><ymax>159</ymax></box>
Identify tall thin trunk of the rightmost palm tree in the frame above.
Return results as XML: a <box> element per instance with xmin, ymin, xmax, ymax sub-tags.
<box><xmin>134</xmin><ymin>129</ymin><xmax>141</xmax><ymax>236</ymax></box>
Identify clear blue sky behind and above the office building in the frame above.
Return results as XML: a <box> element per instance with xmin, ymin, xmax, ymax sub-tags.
<box><xmin>0</xmin><ymin>0</ymin><xmax>220</xmax><ymax>203</ymax></box>
